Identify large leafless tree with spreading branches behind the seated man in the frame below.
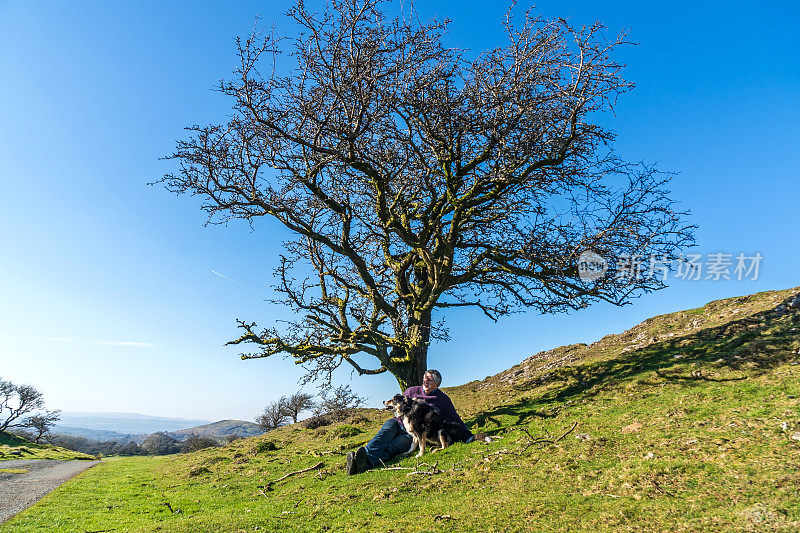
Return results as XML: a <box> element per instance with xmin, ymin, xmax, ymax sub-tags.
<box><xmin>162</xmin><ymin>0</ymin><xmax>693</xmax><ymax>390</ymax></box>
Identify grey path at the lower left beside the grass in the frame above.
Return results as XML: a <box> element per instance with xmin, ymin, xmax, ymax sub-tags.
<box><xmin>0</xmin><ymin>459</ymin><xmax>100</xmax><ymax>524</ymax></box>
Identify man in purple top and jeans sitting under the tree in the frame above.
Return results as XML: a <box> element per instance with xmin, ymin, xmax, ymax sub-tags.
<box><xmin>347</xmin><ymin>369</ymin><xmax>475</xmax><ymax>475</ymax></box>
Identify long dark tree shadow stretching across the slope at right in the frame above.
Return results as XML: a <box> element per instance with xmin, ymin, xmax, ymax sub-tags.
<box><xmin>468</xmin><ymin>295</ymin><xmax>800</xmax><ymax>431</ymax></box>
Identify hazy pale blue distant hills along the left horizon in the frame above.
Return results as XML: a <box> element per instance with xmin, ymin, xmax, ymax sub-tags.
<box><xmin>53</xmin><ymin>412</ymin><xmax>211</xmax><ymax>440</ymax></box>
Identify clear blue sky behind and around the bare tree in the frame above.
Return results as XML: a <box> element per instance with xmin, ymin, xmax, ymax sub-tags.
<box><xmin>0</xmin><ymin>0</ymin><xmax>800</xmax><ymax>419</ymax></box>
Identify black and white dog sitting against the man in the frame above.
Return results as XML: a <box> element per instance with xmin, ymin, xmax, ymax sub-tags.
<box><xmin>383</xmin><ymin>394</ymin><xmax>470</xmax><ymax>457</ymax></box>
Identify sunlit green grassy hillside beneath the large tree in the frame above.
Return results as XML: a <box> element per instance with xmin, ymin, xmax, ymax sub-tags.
<box><xmin>5</xmin><ymin>289</ymin><xmax>800</xmax><ymax>532</ymax></box>
